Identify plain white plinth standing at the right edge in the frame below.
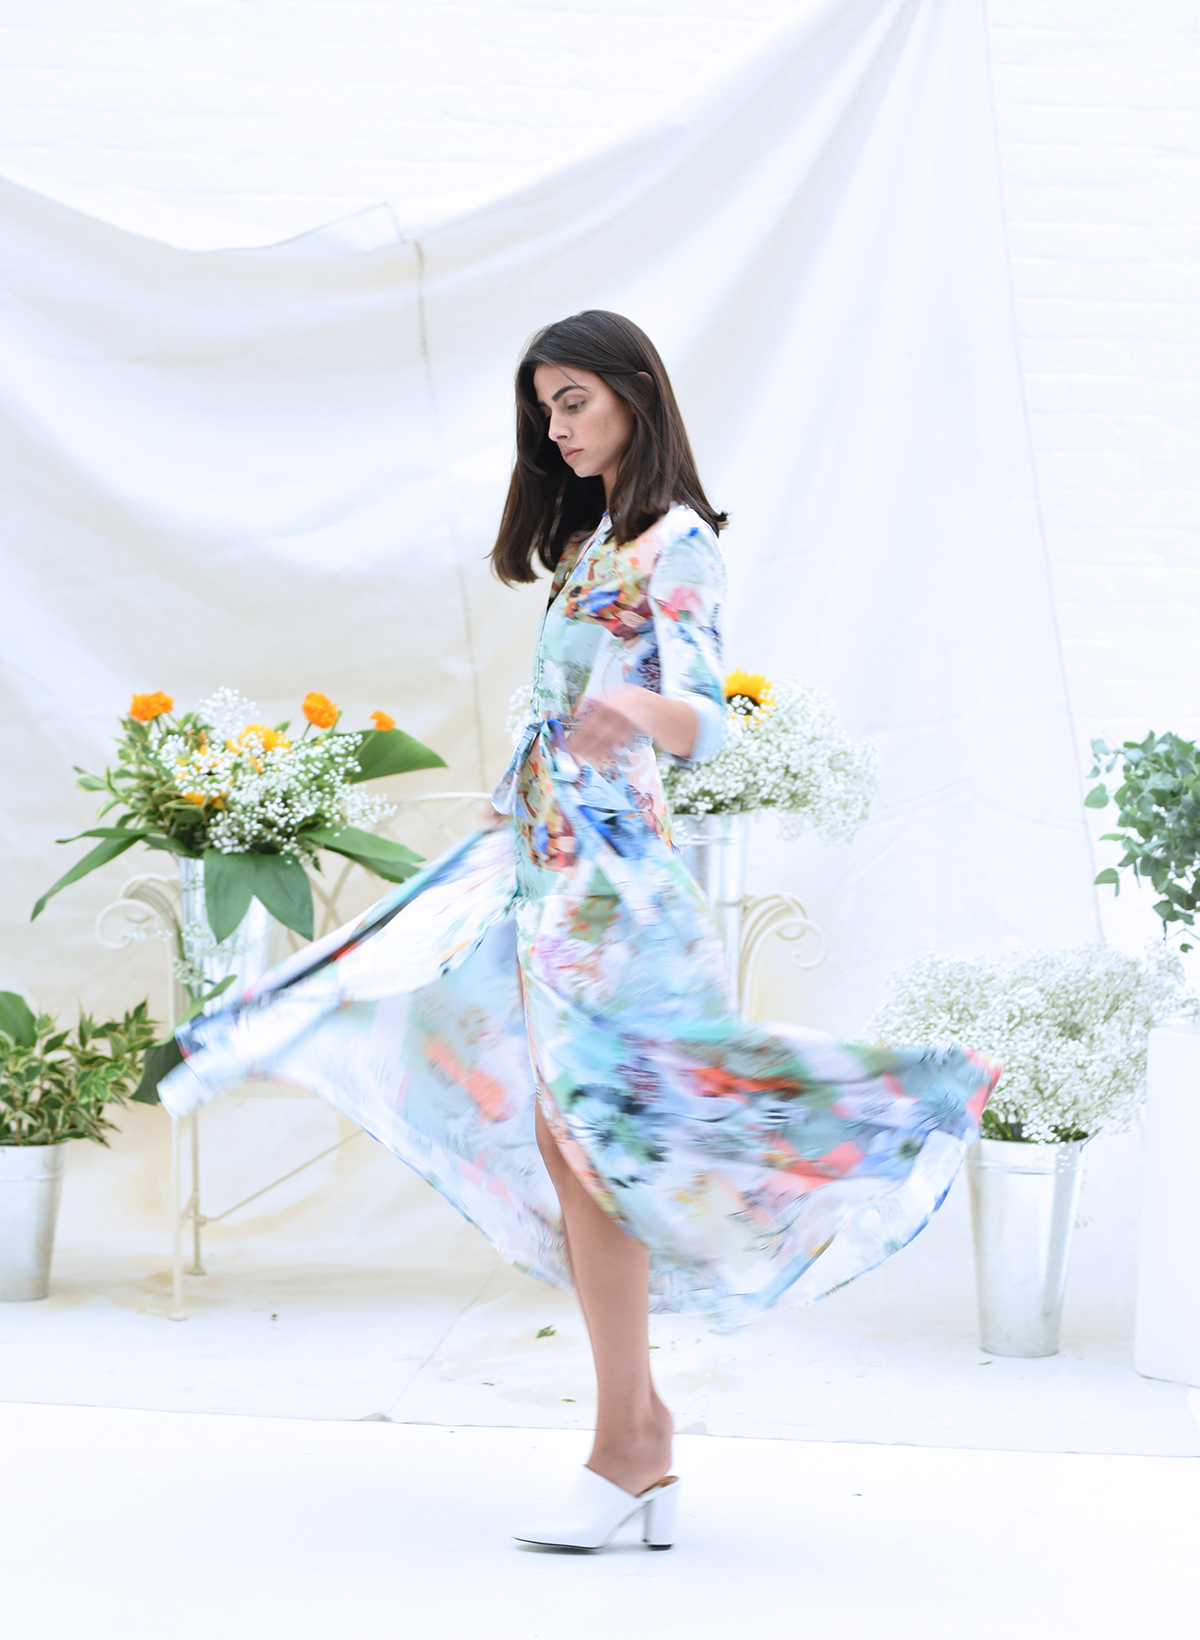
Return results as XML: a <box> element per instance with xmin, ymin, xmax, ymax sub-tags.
<box><xmin>1133</xmin><ymin>1025</ymin><xmax>1200</xmax><ymax>1386</ymax></box>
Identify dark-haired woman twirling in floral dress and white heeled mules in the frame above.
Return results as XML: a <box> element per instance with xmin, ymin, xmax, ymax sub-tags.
<box><xmin>162</xmin><ymin>312</ymin><xmax>998</xmax><ymax>1548</ymax></box>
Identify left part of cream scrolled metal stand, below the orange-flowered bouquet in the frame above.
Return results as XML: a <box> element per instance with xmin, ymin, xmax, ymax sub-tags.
<box><xmin>95</xmin><ymin>792</ymin><xmax>487</xmax><ymax>1322</ymax></box>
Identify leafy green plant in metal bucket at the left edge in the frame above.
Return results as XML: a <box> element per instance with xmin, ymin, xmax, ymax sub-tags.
<box><xmin>0</xmin><ymin>991</ymin><xmax>156</xmax><ymax>1299</ymax></box>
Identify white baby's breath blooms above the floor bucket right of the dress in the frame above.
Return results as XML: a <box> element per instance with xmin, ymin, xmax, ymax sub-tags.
<box><xmin>866</xmin><ymin>945</ymin><xmax>1200</xmax><ymax>1145</ymax></box>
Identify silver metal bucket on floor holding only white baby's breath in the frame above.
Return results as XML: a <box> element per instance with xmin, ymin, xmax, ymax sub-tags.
<box><xmin>967</xmin><ymin>1138</ymin><xmax>1084</xmax><ymax>1356</ymax></box>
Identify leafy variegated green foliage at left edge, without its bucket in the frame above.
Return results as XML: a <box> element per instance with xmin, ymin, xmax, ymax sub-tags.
<box><xmin>0</xmin><ymin>991</ymin><xmax>157</xmax><ymax>1145</ymax></box>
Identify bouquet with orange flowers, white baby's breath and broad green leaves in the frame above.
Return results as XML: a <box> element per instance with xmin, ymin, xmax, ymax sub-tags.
<box><xmin>33</xmin><ymin>689</ymin><xmax>444</xmax><ymax>941</ymax></box>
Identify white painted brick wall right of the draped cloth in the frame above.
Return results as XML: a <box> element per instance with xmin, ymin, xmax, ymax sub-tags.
<box><xmin>989</xmin><ymin>0</ymin><xmax>1200</xmax><ymax>943</ymax></box>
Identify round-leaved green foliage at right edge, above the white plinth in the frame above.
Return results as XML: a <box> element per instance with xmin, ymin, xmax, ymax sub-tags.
<box><xmin>1084</xmin><ymin>733</ymin><xmax>1200</xmax><ymax>951</ymax></box>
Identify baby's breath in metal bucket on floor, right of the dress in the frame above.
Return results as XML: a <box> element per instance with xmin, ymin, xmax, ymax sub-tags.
<box><xmin>869</xmin><ymin>945</ymin><xmax>1197</xmax><ymax>1356</ymax></box>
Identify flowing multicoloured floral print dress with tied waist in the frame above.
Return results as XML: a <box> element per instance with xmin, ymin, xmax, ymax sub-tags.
<box><xmin>161</xmin><ymin>507</ymin><xmax>998</xmax><ymax>1327</ymax></box>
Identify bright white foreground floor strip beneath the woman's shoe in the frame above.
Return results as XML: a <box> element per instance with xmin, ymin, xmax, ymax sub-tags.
<box><xmin>0</xmin><ymin>1405</ymin><xmax>1200</xmax><ymax>1640</ymax></box>
